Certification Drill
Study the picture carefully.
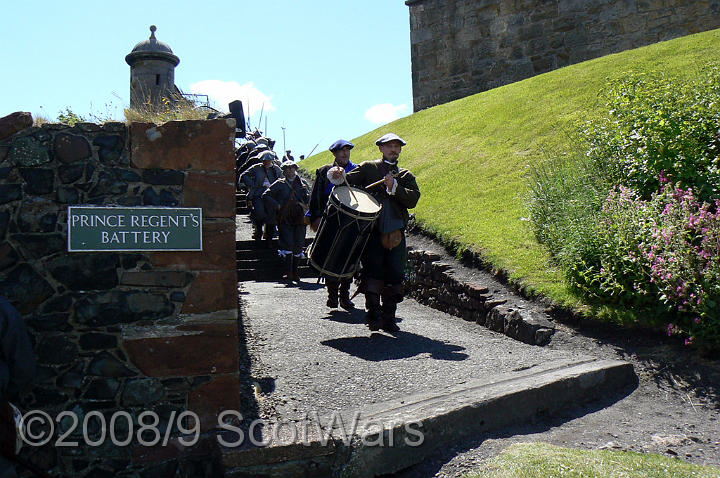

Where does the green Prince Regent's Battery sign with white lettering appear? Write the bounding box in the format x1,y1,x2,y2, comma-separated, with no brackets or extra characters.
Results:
68,206,202,252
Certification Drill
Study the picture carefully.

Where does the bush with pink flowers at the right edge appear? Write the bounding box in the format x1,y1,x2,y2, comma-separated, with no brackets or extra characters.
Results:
566,186,720,346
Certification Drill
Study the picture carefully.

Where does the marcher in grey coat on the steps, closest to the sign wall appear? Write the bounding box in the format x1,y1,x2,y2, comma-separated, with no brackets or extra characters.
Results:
239,151,282,244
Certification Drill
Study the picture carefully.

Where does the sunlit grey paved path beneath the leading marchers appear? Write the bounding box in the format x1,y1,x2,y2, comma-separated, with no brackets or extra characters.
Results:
226,216,632,476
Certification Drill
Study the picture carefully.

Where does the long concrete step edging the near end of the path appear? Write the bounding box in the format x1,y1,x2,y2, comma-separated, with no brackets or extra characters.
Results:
221,360,637,478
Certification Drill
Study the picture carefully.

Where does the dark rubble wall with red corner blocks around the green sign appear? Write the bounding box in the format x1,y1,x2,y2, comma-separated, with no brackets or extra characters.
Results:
0,115,240,478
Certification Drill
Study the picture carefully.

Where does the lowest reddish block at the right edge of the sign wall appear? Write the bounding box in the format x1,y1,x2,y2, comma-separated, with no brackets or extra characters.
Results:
188,374,242,431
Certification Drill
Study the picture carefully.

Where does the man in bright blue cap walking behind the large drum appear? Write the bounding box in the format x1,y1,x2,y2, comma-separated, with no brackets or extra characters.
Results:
308,139,357,310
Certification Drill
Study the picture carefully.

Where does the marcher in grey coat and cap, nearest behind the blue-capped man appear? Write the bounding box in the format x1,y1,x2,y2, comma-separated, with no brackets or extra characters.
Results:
262,160,310,282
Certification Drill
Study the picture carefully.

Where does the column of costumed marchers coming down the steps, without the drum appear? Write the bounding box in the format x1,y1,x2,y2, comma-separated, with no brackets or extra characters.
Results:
238,133,420,332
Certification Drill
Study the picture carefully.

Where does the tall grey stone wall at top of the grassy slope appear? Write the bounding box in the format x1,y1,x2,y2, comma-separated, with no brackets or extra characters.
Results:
405,0,720,111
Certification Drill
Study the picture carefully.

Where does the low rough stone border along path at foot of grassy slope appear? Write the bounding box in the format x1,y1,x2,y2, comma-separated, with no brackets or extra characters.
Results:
405,249,555,345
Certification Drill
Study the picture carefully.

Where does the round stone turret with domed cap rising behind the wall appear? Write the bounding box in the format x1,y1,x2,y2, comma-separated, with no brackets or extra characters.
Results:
125,25,180,109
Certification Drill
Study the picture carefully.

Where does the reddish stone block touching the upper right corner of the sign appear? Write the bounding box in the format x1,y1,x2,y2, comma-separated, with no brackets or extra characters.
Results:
184,171,235,218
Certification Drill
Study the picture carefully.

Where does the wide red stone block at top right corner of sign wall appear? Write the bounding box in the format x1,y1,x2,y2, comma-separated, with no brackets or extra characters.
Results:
130,119,235,172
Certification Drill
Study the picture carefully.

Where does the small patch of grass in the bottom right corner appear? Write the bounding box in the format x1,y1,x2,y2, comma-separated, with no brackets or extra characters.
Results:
465,443,720,478
